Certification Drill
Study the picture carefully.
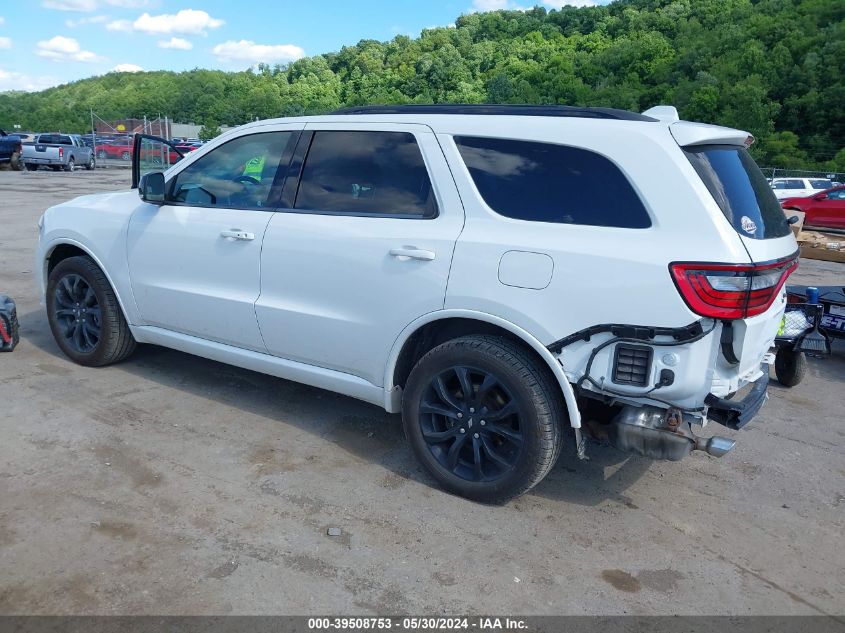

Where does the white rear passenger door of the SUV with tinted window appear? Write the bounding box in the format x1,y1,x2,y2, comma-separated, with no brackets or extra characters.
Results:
256,123,464,386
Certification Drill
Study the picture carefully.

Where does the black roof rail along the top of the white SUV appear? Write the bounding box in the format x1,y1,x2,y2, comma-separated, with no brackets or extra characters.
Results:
332,104,657,121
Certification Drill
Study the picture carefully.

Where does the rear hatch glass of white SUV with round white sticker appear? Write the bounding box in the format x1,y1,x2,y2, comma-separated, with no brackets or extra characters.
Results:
684,145,791,240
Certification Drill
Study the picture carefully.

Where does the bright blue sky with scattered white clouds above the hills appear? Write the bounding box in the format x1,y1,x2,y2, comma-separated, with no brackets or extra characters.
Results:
0,0,608,91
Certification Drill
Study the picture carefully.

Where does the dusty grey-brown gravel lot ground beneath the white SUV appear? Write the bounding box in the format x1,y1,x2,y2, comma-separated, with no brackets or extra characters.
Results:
0,170,845,615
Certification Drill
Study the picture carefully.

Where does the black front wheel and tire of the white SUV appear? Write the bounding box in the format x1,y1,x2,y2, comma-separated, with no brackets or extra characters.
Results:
46,256,136,367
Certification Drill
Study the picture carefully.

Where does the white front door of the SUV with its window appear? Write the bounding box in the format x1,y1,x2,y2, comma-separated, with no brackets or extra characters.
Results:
127,125,302,352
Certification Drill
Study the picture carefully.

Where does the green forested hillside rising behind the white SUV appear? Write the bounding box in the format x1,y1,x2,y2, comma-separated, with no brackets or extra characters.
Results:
0,0,845,171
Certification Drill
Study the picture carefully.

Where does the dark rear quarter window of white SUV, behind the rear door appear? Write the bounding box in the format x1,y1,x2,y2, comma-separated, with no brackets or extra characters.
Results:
455,136,651,229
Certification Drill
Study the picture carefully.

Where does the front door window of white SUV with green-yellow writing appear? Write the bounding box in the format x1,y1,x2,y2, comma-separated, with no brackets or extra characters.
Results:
166,132,297,209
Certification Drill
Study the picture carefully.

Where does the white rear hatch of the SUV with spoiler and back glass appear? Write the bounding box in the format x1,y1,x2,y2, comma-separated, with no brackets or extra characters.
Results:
670,121,798,380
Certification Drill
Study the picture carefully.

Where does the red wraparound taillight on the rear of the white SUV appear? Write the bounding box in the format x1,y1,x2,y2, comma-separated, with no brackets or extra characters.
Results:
669,256,798,319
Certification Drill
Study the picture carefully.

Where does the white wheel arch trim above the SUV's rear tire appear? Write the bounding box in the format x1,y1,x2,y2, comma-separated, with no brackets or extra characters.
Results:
384,310,581,429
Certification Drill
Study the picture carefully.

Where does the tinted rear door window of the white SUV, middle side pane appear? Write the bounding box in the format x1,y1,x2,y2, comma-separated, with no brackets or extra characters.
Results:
295,131,437,217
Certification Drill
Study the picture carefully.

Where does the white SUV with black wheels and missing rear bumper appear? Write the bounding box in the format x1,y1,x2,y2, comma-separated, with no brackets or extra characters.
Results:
37,106,797,502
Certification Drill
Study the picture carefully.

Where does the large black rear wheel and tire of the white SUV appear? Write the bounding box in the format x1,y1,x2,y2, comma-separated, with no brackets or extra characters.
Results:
402,336,563,503
